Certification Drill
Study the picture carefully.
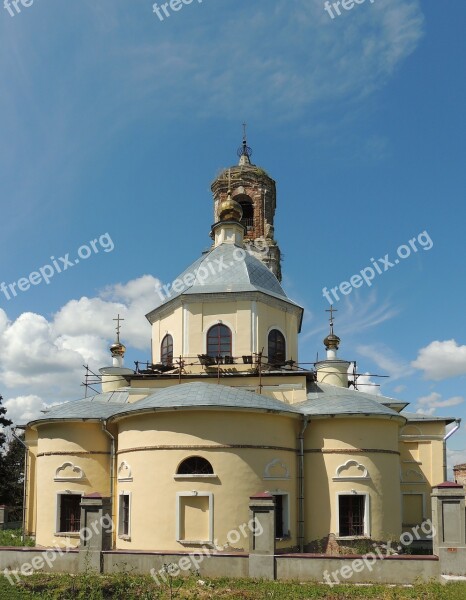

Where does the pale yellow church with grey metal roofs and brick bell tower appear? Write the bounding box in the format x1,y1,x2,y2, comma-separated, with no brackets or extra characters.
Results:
20,140,456,552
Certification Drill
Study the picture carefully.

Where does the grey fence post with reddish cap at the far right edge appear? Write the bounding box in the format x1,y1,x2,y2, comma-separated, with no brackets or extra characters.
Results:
431,481,466,576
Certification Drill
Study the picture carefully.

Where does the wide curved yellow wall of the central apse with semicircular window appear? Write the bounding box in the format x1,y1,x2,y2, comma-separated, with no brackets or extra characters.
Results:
117,411,299,550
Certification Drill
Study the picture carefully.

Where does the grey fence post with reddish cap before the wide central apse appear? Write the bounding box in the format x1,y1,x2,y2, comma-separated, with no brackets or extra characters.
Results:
249,492,275,579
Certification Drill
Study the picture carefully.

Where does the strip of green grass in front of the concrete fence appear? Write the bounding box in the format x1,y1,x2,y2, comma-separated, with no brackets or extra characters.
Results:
0,574,466,600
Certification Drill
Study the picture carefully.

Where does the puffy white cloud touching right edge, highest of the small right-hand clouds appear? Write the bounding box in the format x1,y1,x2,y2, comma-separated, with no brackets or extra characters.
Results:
411,340,466,381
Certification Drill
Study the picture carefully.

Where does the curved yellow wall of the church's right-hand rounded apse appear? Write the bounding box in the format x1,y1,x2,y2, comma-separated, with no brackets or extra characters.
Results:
305,418,401,542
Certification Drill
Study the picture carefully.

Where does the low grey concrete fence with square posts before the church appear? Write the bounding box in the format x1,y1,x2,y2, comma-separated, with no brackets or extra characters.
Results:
0,483,466,585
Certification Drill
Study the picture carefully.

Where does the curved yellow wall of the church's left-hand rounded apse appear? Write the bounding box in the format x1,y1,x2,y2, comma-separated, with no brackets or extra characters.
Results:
35,422,110,546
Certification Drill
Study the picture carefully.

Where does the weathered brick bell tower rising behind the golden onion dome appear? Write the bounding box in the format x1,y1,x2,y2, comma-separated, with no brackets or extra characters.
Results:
211,126,282,281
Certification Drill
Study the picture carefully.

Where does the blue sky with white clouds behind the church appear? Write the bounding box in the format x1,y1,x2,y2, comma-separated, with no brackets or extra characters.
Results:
0,0,466,462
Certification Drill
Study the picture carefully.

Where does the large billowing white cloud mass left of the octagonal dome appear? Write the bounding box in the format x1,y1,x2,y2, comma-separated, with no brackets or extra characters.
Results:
0,275,160,423
